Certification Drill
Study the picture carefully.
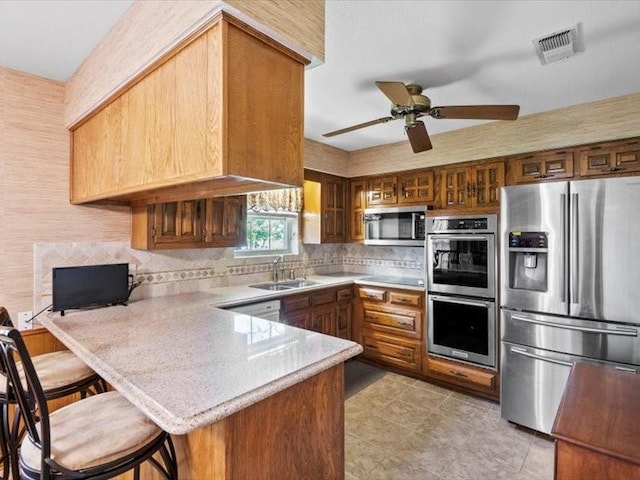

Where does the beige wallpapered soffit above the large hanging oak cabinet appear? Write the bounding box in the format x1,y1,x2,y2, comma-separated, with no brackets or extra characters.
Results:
65,0,324,125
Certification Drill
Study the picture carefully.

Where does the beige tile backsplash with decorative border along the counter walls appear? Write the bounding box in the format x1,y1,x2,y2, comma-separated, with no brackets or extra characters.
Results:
34,242,424,311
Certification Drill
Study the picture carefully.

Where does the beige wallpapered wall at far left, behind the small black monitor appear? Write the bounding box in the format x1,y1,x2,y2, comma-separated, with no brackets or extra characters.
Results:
0,68,130,320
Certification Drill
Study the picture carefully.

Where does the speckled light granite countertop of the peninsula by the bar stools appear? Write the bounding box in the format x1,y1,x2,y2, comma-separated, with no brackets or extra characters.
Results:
40,292,362,434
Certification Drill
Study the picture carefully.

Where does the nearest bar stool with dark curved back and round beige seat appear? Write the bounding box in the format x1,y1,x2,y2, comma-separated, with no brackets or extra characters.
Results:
0,327,178,480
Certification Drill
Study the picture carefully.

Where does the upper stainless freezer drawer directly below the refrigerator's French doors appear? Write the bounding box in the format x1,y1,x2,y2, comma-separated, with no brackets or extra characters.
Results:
500,309,640,365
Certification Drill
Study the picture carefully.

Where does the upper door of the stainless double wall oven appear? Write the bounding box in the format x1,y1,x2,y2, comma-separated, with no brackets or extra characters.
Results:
427,234,496,298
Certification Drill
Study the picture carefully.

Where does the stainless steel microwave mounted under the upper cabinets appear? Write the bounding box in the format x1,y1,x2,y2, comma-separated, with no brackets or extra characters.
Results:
364,206,427,247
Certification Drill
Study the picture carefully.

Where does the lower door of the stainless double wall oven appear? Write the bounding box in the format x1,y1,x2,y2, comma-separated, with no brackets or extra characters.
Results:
427,295,497,368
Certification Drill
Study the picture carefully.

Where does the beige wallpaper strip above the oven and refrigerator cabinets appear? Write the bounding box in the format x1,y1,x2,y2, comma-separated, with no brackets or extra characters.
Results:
343,93,640,177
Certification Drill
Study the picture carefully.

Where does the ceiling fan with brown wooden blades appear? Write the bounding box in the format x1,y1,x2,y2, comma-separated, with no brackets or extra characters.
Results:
323,82,520,153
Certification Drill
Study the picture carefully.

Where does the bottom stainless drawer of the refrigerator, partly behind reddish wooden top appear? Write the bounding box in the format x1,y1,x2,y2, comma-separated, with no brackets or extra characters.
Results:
500,342,640,434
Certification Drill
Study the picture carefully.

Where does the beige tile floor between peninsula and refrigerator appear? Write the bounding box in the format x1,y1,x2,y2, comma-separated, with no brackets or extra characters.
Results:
345,362,553,480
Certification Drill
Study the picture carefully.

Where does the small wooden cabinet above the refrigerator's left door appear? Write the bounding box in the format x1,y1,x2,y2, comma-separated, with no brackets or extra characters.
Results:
509,150,573,185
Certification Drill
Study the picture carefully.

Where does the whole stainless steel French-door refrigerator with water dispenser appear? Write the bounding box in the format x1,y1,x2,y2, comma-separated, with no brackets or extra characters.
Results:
500,177,640,433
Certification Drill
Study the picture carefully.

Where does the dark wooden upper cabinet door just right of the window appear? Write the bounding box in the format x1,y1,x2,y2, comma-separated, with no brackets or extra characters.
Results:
321,176,347,243
